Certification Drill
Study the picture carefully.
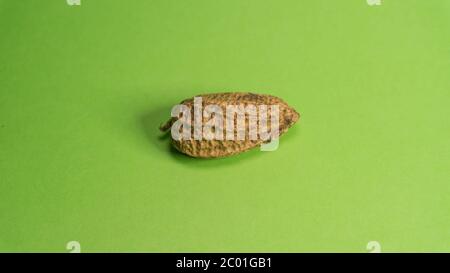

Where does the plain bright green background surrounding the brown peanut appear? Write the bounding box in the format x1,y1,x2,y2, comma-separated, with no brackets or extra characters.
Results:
0,0,450,252
